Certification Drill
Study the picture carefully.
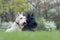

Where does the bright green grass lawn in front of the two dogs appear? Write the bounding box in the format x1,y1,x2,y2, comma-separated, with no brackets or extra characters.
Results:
0,31,60,40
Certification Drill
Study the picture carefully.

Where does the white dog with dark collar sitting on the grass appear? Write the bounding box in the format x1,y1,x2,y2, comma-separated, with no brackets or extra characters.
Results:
6,12,26,32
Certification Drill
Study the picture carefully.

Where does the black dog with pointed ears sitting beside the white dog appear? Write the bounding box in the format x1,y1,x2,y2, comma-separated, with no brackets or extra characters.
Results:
23,14,37,31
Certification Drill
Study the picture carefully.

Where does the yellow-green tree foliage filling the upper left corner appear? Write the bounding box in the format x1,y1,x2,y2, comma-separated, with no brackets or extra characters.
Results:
0,0,27,14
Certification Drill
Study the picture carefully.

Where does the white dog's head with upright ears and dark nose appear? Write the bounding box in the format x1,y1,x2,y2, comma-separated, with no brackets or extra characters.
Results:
15,12,27,26
